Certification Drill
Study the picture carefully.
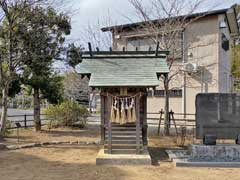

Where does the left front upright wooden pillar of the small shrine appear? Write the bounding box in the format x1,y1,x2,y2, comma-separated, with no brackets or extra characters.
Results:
107,96,112,154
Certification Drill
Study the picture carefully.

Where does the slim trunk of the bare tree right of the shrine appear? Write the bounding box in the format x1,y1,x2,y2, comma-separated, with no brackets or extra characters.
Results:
164,75,170,136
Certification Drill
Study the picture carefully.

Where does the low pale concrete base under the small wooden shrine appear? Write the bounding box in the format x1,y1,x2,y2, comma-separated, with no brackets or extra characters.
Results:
96,149,152,165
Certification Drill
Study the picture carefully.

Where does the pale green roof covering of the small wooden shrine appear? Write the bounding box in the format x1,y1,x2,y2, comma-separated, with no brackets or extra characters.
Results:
77,57,169,87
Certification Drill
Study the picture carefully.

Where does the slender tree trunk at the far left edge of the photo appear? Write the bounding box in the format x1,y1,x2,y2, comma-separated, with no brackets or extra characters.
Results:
0,86,8,136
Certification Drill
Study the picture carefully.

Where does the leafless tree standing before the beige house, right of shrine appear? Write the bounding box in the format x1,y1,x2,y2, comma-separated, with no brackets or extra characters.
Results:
129,0,220,135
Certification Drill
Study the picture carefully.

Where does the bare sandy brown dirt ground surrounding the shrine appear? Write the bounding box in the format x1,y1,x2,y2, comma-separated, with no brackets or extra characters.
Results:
0,128,240,180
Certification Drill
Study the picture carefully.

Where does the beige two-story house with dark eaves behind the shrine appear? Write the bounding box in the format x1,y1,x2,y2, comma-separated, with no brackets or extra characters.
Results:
102,8,239,113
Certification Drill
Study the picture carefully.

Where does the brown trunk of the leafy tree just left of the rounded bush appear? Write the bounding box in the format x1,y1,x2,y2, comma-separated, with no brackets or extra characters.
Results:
33,88,41,131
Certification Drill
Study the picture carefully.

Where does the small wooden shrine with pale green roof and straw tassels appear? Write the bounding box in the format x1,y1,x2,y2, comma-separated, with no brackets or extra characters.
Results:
78,51,169,154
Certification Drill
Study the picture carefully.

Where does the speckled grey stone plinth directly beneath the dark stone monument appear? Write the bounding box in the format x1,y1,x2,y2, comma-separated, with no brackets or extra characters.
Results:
189,144,240,159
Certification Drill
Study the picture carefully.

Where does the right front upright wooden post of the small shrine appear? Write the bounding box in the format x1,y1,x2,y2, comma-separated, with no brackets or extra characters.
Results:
136,96,140,154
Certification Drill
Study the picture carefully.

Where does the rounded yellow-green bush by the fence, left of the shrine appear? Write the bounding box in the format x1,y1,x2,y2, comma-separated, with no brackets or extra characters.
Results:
44,101,89,128
